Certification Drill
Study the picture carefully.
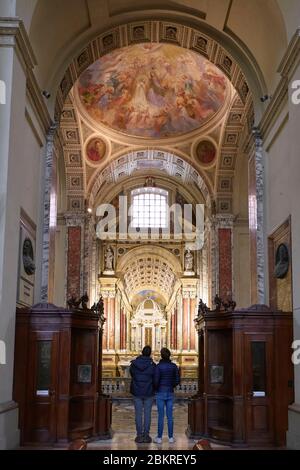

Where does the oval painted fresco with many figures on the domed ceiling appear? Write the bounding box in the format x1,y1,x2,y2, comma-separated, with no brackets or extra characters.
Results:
77,44,227,139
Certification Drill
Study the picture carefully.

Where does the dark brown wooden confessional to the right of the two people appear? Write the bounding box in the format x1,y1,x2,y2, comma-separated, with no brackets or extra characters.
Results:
187,305,294,446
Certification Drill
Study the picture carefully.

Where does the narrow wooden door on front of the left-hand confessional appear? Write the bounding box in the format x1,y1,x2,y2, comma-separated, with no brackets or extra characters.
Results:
24,331,59,443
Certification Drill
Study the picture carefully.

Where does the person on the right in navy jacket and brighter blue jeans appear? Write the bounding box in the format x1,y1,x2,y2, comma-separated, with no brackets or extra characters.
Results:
154,348,180,444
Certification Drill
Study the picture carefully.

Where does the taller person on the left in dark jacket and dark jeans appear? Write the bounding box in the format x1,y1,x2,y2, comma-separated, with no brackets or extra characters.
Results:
129,346,155,443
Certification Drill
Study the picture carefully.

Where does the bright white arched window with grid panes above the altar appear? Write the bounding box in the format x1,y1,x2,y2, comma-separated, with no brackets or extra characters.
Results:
131,187,168,228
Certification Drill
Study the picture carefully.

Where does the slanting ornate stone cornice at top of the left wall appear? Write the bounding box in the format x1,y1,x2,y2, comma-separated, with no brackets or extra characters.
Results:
0,18,51,134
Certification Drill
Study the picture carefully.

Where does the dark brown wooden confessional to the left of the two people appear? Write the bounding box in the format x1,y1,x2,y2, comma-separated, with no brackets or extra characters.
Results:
14,304,111,445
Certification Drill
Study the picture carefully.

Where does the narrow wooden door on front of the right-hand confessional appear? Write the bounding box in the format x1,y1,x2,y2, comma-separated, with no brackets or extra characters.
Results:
244,334,274,446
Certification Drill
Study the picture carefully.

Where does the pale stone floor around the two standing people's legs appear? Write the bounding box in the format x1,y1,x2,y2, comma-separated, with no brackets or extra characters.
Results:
88,402,226,450
